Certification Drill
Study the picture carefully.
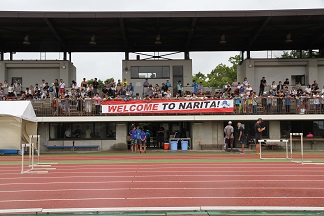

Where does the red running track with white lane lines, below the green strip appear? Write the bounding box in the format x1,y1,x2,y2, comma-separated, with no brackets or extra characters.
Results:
0,162,324,209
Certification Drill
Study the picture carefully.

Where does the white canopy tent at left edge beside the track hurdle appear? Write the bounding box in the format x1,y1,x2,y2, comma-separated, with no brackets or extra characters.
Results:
0,101,37,150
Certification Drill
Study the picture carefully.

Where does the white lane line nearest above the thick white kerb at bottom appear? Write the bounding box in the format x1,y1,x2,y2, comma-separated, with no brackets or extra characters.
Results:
0,196,324,203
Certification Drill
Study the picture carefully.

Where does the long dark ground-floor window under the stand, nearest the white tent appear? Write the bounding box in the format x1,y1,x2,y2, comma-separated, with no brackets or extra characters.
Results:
49,122,116,140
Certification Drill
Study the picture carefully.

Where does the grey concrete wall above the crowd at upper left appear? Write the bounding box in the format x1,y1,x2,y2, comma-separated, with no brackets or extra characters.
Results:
0,60,76,88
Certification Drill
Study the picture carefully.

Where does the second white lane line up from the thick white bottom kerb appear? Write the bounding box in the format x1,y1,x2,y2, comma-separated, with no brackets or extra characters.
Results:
0,187,324,194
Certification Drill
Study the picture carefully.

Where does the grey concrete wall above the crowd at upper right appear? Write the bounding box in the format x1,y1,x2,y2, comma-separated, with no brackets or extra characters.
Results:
237,59,324,92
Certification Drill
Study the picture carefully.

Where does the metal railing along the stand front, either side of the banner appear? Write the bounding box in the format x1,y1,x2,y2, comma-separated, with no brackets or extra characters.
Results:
24,97,324,117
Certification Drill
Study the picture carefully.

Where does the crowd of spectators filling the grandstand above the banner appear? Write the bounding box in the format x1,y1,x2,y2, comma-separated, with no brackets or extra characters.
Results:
0,77,324,115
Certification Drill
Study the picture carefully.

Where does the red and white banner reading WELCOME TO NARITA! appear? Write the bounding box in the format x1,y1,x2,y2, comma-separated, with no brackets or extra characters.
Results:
102,100,234,114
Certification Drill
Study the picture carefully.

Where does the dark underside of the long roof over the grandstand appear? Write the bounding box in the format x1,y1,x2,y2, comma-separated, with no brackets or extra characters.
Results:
0,9,324,52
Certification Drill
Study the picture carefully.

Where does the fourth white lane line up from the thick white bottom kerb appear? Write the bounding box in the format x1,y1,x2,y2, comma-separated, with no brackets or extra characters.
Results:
0,173,324,181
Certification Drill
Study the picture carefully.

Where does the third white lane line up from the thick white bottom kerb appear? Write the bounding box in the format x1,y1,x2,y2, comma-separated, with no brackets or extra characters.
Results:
0,179,324,186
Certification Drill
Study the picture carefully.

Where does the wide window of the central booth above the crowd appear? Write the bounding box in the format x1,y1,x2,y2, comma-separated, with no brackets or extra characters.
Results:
131,66,170,79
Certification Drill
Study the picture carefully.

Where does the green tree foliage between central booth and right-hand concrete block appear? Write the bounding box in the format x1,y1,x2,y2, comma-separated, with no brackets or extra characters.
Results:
192,55,240,88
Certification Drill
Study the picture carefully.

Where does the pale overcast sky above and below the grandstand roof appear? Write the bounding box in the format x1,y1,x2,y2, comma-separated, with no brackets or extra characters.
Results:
0,0,324,83
